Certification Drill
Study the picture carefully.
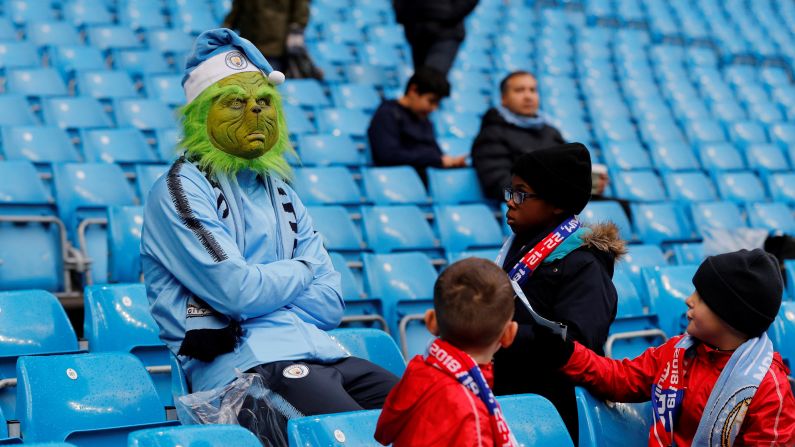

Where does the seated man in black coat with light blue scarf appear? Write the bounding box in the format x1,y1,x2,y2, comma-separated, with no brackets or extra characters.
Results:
472,71,564,200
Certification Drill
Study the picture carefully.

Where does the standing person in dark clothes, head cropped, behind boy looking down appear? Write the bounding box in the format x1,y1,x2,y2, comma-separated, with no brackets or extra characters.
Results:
393,0,478,75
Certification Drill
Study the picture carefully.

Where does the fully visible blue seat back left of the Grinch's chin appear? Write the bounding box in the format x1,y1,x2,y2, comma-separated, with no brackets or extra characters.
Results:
81,128,159,166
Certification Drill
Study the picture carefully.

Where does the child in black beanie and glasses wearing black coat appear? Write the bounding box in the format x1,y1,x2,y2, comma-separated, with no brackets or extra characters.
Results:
494,143,625,444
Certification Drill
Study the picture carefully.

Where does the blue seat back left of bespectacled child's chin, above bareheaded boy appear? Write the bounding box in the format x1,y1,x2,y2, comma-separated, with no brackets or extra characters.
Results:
434,204,503,252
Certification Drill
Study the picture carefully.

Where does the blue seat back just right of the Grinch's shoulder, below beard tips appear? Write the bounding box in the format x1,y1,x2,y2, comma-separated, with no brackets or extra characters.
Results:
293,166,363,205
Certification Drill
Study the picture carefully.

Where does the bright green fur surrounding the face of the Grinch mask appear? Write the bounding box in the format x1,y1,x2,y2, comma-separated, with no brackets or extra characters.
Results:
177,78,298,180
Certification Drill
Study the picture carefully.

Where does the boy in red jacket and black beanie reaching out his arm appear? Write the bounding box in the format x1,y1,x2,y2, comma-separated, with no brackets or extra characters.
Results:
543,249,795,447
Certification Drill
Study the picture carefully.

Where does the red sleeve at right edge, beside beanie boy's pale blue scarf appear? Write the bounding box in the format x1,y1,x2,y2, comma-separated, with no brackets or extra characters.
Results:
737,360,795,446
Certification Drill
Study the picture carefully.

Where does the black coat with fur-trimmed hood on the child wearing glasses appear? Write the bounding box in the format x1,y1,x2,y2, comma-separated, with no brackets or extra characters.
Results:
494,224,625,445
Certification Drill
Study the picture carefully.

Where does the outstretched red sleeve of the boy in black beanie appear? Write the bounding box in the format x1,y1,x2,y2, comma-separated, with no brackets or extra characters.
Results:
561,337,679,402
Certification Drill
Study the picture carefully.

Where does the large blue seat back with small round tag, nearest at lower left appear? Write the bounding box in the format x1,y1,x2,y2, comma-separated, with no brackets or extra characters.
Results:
17,353,176,446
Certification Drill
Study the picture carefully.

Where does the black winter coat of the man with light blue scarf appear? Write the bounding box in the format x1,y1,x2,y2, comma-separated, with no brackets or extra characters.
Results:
472,109,565,200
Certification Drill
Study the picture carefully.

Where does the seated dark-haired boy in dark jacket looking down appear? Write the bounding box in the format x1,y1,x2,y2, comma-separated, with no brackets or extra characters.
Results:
367,68,466,181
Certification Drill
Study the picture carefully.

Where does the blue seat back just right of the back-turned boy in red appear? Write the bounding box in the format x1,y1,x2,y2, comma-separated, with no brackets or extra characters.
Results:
497,394,574,447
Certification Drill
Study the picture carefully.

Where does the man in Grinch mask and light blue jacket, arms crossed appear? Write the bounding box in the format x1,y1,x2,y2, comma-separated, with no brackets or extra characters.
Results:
141,29,397,442
